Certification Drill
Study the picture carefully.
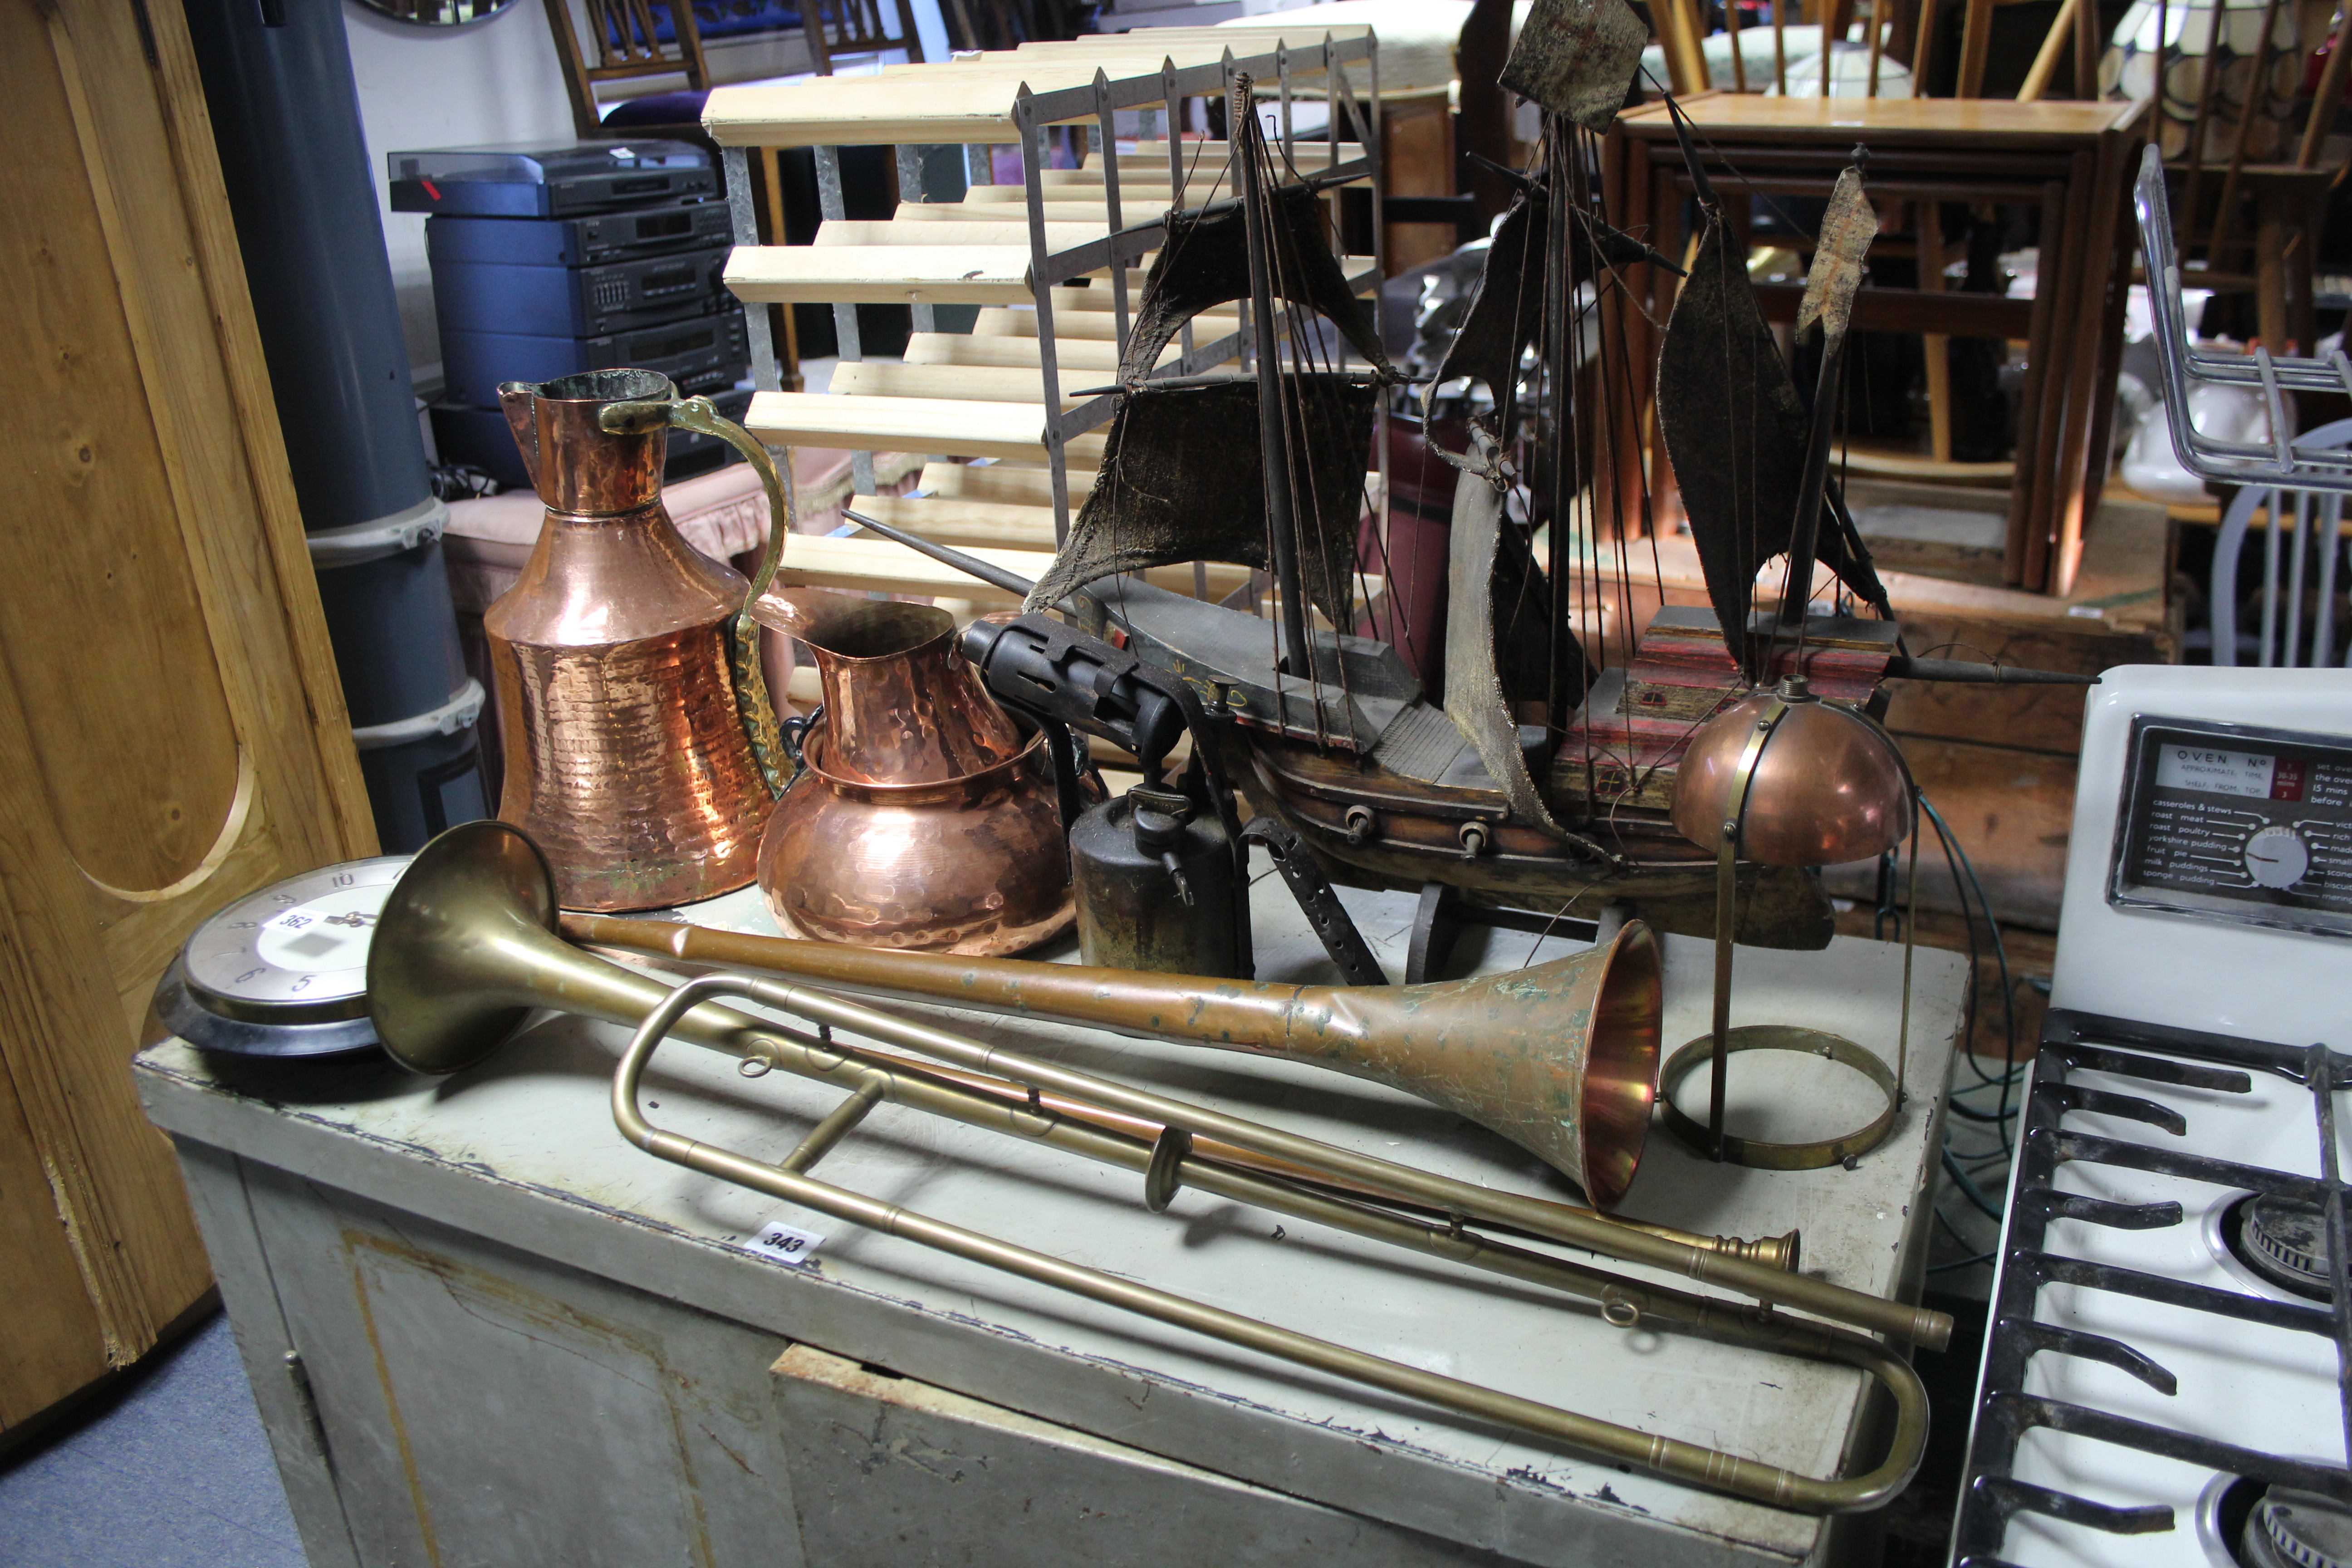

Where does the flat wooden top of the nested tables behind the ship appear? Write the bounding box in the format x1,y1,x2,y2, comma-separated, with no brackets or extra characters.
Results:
1618,92,2147,153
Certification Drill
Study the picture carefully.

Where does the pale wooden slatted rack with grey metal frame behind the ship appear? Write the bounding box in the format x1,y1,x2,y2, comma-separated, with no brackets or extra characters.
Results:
703,26,1385,592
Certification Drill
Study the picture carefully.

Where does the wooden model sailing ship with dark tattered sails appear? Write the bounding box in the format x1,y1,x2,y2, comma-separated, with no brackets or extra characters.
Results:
870,0,2077,947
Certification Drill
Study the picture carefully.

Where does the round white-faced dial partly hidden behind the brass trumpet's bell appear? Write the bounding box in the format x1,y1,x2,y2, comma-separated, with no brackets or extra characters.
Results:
155,856,412,1058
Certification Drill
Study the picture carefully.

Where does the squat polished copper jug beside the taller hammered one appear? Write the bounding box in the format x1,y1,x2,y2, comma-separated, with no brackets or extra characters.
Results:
753,590,1075,957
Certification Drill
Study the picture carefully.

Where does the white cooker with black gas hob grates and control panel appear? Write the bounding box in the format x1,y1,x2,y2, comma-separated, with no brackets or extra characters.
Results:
1952,665,2352,1568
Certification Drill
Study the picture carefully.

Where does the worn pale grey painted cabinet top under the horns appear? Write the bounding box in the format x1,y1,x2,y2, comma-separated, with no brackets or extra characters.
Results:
139,877,1966,1563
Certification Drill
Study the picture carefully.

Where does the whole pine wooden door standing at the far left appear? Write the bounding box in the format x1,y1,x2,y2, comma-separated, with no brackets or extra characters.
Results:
0,0,376,1425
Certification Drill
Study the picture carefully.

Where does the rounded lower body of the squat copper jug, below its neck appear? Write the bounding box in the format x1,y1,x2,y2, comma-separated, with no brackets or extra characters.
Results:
760,720,1077,957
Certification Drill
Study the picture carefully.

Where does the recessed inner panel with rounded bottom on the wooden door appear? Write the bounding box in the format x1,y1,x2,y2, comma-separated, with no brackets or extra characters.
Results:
0,7,238,893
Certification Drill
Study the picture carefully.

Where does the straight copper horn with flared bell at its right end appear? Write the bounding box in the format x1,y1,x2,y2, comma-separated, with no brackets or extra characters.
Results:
562,879,1663,1208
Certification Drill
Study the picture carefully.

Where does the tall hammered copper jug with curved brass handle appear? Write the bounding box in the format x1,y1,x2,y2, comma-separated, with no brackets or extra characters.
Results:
482,369,788,910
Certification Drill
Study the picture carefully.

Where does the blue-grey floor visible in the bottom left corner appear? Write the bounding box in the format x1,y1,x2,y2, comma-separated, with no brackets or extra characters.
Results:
0,1314,304,1568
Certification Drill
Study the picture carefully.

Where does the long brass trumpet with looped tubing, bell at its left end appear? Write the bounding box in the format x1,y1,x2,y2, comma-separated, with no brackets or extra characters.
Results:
367,820,1952,1514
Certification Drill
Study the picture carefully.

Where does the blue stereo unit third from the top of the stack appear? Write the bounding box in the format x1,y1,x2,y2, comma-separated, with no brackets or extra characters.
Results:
433,245,734,338
